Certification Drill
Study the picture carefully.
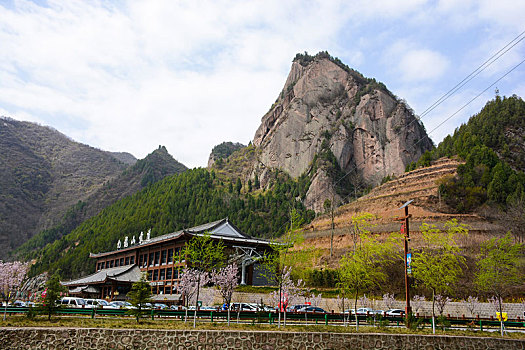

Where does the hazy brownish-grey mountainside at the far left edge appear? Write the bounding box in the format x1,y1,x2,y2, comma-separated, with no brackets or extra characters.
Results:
0,117,127,259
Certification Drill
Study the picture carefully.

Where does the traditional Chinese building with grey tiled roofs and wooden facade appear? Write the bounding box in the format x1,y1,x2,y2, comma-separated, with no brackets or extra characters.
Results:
62,219,270,303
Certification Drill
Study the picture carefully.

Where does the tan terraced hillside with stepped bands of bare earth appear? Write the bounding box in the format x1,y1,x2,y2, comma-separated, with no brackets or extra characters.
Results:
296,158,500,265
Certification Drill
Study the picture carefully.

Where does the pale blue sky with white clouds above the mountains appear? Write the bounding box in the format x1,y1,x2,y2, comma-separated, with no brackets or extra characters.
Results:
0,0,525,167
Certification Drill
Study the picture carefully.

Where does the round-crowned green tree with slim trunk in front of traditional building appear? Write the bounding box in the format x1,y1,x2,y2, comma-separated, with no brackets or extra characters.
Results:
182,233,226,327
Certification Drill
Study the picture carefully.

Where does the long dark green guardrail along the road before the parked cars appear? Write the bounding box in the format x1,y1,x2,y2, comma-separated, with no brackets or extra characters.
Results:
0,307,525,331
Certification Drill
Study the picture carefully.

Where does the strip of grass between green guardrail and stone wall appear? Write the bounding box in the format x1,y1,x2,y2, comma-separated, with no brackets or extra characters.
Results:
0,316,525,340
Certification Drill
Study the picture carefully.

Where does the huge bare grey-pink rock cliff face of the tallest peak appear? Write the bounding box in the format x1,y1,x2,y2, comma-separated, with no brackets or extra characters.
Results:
253,54,432,211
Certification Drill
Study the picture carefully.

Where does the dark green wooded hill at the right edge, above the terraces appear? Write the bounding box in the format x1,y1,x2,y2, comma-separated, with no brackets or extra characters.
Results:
407,95,525,213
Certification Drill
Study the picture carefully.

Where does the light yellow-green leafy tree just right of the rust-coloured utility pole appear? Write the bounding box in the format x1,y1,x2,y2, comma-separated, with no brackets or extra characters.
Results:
412,219,468,333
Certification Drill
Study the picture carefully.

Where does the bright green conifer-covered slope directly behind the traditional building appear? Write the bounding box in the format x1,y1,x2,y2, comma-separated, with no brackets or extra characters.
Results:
27,169,314,278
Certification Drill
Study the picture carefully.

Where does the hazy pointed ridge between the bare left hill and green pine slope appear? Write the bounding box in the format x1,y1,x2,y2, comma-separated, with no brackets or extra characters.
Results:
15,146,187,256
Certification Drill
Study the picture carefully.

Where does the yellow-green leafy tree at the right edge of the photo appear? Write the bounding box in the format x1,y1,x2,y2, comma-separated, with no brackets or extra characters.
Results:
475,233,524,336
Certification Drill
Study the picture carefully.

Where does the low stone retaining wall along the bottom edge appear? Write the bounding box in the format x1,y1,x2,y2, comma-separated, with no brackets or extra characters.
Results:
0,328,525,350
